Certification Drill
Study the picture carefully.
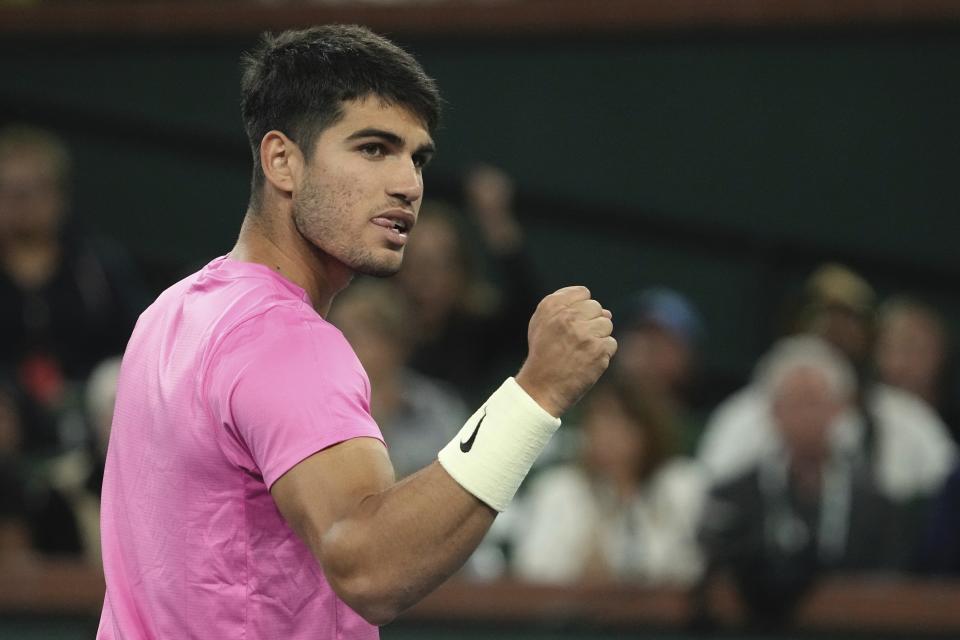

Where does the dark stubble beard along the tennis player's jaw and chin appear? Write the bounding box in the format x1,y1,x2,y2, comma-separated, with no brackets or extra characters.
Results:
293,184,403,278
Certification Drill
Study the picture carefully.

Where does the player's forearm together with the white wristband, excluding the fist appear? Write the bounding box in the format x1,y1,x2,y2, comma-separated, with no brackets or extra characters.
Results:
314,380,560,622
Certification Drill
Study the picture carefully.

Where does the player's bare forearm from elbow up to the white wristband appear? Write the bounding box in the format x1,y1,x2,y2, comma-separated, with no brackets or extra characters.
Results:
312,463,496,624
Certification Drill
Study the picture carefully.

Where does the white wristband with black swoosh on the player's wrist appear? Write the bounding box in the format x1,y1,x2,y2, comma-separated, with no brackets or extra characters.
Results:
437,378,560,511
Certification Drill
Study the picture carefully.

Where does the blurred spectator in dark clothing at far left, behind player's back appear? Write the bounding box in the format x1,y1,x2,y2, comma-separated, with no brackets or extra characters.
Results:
0,125,146,451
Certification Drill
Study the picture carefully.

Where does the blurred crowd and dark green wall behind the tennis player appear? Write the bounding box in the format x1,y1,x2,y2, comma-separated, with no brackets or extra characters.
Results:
0,0,960,637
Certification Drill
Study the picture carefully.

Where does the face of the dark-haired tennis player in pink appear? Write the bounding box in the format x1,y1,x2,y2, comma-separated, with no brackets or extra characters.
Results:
291,98,433,276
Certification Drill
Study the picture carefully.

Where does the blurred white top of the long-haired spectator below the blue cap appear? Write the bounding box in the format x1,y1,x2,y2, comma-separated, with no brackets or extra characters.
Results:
513,458,706,585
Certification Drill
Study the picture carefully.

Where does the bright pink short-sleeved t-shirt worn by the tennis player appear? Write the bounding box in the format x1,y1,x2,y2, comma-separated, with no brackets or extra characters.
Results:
97,258,382,640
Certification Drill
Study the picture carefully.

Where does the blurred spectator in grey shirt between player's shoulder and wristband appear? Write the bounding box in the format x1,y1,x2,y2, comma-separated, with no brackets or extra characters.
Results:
330,280,470,478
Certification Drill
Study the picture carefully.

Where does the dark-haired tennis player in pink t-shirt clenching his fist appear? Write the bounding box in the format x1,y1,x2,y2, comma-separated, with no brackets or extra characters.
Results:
97,26,616,640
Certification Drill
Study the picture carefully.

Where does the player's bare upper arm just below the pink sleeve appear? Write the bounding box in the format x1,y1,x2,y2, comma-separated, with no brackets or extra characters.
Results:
270,437,395,555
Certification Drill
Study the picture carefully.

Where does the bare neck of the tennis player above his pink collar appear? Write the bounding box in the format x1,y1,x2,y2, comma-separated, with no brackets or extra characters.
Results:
230,208,353,318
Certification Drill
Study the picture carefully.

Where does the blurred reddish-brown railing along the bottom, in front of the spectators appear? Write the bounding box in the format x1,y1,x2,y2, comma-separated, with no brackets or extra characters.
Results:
0,562,960,637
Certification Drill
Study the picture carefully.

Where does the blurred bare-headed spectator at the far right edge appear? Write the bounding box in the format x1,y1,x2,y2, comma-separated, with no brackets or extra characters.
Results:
874,296,960,439
